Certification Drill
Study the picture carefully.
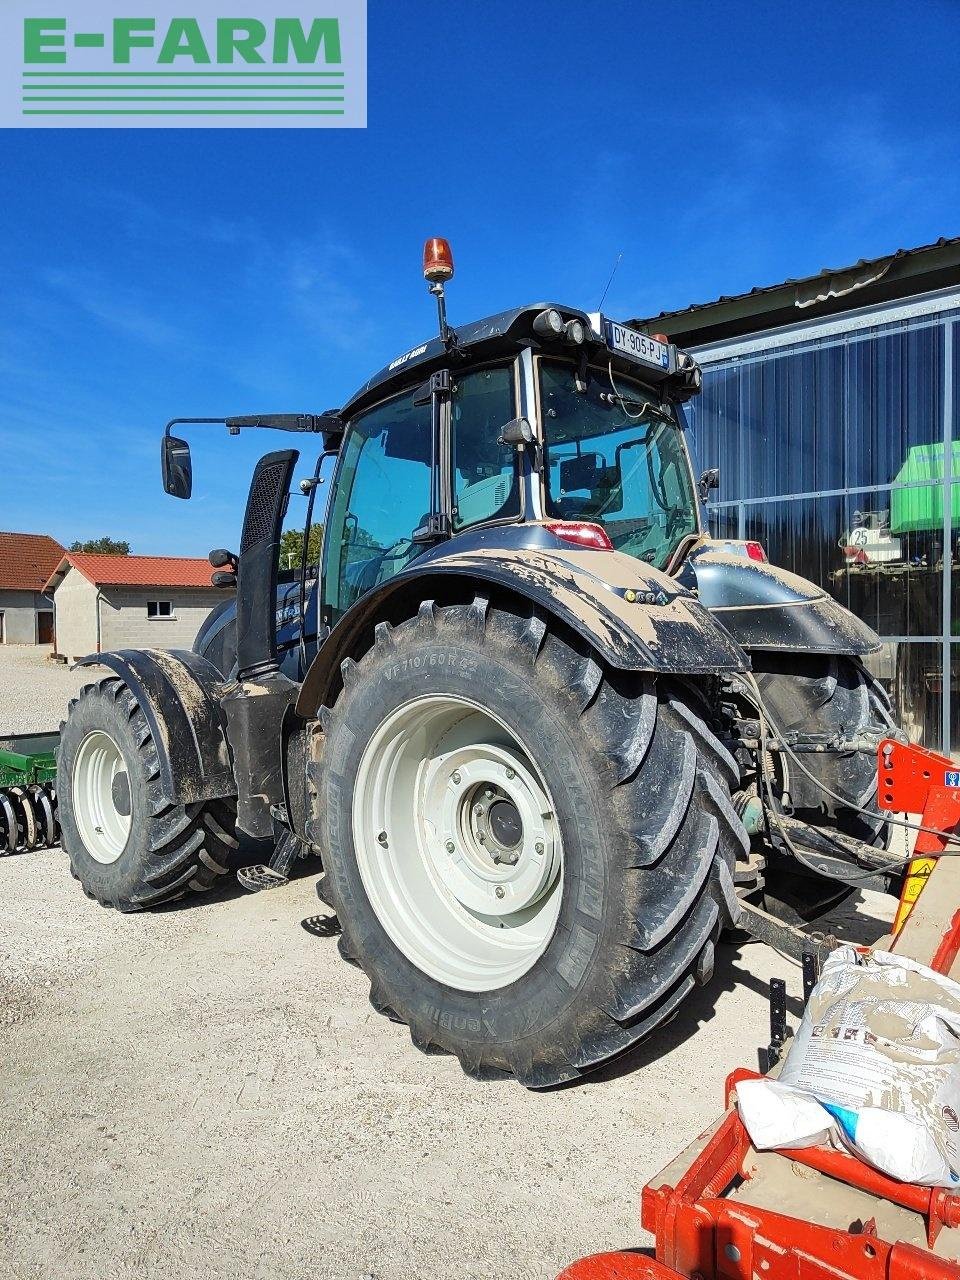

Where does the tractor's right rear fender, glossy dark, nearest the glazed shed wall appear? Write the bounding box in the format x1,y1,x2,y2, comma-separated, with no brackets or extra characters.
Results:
687,543,881,658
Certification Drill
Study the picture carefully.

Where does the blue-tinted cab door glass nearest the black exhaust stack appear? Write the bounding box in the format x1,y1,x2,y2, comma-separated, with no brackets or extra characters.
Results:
324,392,431,625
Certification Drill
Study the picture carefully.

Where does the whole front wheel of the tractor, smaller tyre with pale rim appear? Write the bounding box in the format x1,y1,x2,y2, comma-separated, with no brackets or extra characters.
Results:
56,676,237,911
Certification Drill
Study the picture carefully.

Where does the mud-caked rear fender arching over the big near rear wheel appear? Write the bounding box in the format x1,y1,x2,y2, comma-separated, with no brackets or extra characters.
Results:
297,526,749,718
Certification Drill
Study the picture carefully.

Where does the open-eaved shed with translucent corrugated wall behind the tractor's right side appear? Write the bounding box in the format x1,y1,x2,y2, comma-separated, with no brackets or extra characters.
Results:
632,237,960,751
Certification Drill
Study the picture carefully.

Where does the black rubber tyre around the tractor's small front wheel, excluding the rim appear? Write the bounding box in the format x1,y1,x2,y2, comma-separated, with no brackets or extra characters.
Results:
56,676,237,911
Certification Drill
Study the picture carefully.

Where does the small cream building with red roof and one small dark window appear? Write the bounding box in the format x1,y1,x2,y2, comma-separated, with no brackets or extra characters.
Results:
46,552,232,662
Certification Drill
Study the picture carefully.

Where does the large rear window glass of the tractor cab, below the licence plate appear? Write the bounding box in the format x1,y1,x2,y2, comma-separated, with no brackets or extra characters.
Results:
540,361,699,568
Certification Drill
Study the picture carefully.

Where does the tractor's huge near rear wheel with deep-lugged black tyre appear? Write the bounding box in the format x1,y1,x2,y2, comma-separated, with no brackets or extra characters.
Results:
315,598,748,1088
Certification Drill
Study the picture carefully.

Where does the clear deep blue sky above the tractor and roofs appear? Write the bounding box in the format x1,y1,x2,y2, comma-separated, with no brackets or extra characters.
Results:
0,0,960,556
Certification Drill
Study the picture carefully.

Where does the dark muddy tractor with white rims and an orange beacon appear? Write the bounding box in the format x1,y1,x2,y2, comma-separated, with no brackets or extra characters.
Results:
58,239,897,1087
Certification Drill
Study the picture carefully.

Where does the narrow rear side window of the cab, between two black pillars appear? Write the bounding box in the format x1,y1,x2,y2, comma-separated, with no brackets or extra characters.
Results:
451,365,520,531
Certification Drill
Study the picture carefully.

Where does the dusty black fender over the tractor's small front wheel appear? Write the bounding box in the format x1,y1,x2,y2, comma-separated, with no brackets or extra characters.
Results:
76,649,237,804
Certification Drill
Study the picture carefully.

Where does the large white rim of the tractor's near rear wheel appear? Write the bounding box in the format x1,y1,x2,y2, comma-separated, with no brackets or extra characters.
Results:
352,695,563,991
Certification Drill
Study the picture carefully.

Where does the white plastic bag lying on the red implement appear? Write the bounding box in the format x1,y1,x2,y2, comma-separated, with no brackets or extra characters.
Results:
736,947,960,1188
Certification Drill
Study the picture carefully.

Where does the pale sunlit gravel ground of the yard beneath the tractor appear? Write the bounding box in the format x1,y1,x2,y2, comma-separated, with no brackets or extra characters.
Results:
0,650,892,1280
